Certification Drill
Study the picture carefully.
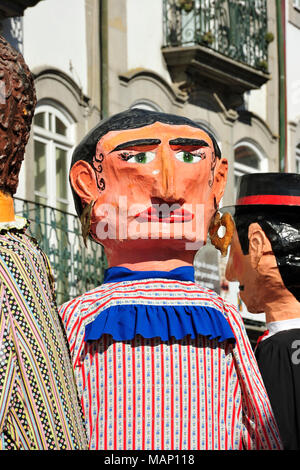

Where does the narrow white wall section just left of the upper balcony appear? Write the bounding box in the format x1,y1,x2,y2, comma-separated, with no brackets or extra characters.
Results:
127,0,171,83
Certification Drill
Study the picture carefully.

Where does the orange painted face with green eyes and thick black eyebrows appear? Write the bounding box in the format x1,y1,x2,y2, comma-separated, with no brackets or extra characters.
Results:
91,122,218,252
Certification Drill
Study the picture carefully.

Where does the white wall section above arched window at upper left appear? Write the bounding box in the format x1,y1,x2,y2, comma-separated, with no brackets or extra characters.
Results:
24,0,87,94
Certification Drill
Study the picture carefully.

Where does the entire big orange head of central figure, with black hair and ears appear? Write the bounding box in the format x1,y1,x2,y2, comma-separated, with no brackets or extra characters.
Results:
70,109,227,265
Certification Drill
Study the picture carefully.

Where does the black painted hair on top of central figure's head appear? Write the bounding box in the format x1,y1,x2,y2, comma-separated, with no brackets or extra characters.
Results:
71,108,221,216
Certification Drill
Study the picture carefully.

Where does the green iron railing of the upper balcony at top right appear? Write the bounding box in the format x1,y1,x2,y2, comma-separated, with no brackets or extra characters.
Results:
164,0,273,72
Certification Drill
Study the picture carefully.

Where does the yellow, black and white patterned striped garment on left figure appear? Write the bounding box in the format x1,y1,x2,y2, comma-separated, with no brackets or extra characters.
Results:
0,219,87,450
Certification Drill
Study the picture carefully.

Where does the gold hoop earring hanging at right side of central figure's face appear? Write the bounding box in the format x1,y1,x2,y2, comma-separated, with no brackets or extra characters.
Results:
208,212,234,256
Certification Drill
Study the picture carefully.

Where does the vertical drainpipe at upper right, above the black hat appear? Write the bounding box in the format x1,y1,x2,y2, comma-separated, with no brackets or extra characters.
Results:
276,0,287,172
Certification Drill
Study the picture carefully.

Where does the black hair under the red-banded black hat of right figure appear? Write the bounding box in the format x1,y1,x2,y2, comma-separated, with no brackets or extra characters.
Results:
234,206,300,301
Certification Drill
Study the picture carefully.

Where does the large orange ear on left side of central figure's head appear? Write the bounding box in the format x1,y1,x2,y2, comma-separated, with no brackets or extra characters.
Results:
70,160,99,204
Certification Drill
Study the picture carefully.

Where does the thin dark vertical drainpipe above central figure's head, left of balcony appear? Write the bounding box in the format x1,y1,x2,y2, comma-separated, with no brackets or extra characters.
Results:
99,0,108,119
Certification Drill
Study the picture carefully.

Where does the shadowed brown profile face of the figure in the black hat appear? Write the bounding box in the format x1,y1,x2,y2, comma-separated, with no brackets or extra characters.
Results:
225,230,264,313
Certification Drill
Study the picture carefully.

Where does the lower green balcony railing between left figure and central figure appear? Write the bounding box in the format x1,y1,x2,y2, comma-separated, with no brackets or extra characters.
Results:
14,198,107,305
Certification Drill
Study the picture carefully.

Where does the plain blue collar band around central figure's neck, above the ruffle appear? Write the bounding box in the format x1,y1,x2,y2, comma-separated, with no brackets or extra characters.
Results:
103,266,195,284
